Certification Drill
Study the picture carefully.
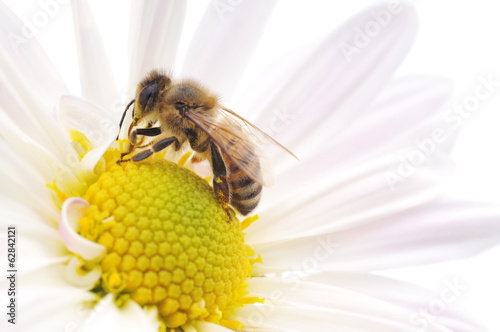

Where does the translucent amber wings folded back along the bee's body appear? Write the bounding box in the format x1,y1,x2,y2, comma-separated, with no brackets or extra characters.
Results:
186,108,297,186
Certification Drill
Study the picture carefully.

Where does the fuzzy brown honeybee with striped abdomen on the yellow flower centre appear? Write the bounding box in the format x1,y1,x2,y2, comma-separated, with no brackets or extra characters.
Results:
118,70,296,220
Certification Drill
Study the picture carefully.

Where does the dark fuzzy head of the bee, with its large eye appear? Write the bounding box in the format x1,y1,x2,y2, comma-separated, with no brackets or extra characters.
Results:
132,70,172,125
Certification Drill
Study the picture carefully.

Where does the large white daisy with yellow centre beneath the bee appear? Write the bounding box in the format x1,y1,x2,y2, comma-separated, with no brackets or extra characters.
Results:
0,1,500,332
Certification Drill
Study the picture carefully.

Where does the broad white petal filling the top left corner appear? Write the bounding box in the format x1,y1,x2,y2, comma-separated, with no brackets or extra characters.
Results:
0,3,73,159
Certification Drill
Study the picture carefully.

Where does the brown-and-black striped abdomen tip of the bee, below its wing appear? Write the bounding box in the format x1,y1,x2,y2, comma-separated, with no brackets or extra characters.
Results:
229,173,262,215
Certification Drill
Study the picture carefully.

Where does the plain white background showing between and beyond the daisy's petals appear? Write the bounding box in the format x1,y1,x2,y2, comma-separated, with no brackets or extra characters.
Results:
6,0,500,331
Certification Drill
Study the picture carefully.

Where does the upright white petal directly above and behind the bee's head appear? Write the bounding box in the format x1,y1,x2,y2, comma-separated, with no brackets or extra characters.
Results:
128,0,187,96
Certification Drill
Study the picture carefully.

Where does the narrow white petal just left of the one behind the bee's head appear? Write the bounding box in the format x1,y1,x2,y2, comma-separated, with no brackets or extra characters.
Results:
71,0,120,109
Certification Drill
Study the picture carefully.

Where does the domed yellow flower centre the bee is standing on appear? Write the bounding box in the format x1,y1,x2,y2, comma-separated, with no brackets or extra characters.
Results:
55,134,260,331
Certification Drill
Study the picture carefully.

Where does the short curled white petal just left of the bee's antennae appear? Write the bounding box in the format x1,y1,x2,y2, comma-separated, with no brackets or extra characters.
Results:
58,96,118,174
